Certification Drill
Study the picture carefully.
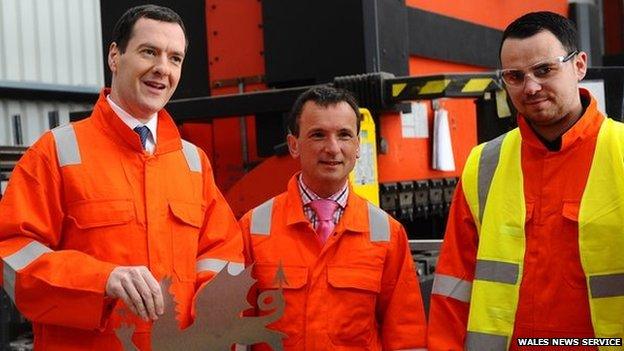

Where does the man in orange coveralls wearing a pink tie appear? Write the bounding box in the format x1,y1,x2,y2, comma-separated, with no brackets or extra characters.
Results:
240,87,425,350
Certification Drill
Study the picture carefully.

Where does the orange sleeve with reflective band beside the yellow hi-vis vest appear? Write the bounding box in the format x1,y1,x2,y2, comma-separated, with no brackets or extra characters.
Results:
427,181,479,351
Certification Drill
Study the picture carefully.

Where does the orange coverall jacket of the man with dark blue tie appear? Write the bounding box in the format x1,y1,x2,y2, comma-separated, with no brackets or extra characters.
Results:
0,90,243,351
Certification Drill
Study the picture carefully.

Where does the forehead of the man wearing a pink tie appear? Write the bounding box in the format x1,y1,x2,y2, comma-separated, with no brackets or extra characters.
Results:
299,101,357,131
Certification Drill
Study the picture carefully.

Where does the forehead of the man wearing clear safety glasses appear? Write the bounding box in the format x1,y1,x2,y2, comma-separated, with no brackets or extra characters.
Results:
501,30,567,68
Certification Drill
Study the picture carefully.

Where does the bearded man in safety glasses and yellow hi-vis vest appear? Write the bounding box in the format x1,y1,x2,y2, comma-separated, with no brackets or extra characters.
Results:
428,12,624,351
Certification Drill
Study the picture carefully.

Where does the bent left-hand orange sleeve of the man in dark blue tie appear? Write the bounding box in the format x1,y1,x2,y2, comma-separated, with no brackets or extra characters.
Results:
0,139,114,329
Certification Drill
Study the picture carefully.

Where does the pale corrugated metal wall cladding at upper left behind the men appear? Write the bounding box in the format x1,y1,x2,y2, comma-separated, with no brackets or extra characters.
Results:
0,0,104,145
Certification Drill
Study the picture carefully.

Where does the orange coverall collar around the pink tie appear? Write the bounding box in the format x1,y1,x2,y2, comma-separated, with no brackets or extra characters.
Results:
285,172,368,232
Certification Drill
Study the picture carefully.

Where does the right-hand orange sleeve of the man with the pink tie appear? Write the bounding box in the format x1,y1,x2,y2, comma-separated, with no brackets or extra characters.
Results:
377,220,427,350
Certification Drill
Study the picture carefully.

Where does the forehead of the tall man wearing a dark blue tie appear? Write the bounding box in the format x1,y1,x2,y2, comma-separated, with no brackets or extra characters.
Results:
128,17,186,52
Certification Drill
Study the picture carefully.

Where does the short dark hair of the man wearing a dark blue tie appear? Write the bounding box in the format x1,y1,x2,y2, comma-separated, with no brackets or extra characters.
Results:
113,4,188,54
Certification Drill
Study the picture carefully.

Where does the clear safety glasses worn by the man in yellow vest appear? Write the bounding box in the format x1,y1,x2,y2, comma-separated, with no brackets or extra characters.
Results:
498,50,578,87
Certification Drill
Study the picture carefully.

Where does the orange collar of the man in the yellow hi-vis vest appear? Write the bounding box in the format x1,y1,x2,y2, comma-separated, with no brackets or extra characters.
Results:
518,88,605,153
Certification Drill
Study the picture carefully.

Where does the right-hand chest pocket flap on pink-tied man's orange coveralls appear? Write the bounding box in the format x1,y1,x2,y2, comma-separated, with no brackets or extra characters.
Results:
327,266,381,293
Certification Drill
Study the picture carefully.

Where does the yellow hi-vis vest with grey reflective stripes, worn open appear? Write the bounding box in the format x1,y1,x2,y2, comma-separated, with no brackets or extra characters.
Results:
462,119,624,351
